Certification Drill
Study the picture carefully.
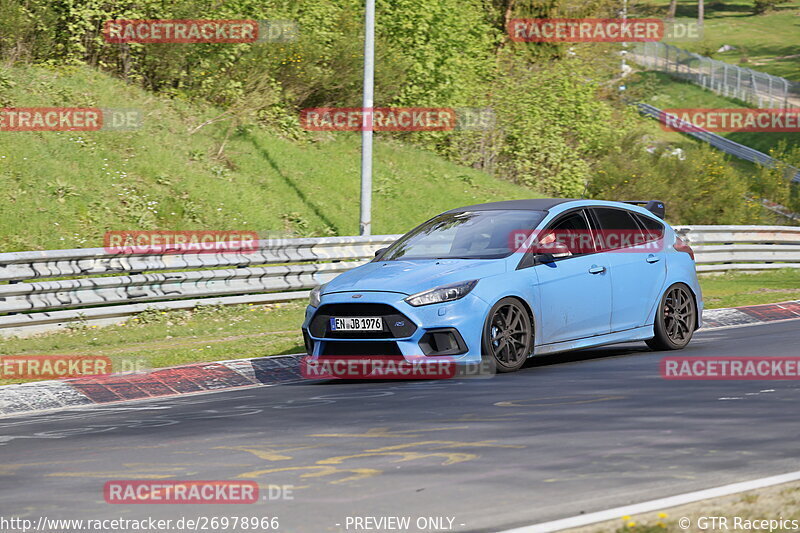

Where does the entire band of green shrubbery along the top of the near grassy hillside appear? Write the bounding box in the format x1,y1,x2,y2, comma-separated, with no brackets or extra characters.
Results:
0,0,783,223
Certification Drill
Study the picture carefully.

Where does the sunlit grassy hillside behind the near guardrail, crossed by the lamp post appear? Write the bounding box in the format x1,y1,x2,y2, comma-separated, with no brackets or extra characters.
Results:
0,66,538,251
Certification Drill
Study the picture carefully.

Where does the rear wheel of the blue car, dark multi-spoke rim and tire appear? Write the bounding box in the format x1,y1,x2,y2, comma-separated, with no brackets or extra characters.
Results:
645,283,697,351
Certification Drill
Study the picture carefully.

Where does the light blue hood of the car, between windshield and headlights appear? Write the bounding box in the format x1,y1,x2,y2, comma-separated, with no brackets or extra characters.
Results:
323,259,506,295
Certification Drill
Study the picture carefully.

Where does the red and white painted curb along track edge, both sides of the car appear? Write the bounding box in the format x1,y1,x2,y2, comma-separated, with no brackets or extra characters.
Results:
0,300,800,416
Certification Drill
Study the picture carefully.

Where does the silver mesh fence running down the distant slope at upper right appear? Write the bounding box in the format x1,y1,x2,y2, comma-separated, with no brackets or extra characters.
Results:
630,42,800,108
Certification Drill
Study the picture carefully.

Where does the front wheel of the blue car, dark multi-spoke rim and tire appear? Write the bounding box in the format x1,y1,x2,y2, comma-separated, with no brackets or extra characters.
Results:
481,298,533,372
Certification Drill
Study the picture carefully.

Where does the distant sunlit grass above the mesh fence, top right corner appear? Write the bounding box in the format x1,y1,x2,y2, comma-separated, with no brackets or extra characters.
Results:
632,0,800,81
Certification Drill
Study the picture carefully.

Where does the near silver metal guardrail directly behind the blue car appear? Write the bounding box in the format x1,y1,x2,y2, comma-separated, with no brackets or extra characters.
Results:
0,226,800,336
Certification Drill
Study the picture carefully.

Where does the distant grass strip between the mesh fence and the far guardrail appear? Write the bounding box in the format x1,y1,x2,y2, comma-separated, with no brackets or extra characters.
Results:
630,71,800,153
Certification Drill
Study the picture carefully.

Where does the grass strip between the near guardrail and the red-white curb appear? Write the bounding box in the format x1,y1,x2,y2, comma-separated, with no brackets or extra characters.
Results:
0,269,800,384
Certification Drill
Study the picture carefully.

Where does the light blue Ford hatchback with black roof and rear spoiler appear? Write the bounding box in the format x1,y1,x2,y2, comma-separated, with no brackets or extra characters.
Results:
303,199,703,372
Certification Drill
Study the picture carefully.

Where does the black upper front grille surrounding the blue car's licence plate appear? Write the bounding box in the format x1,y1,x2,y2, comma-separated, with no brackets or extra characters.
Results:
308,303,417,339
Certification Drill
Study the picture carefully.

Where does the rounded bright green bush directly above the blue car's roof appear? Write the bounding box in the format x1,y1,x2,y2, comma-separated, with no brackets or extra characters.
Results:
439,51,619,197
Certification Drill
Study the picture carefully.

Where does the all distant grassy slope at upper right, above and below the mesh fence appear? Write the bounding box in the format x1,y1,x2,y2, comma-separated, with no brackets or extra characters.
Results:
629,0,800,212
